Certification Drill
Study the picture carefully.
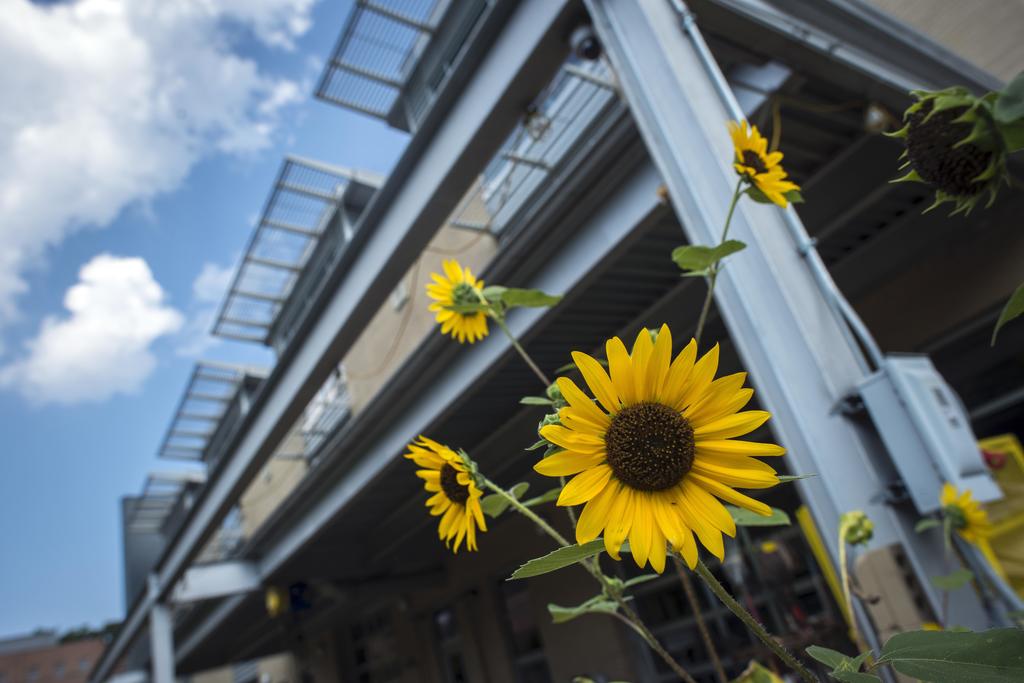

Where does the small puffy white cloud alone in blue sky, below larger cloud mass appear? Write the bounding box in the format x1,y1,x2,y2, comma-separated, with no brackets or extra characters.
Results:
0,254,183,403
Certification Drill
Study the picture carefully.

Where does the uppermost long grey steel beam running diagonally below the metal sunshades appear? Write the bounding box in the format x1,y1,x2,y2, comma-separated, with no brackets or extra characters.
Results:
90,0,572,681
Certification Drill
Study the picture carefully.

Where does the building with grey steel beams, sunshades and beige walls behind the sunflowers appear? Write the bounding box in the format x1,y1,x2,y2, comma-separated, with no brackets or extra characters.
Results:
97,0,1024,683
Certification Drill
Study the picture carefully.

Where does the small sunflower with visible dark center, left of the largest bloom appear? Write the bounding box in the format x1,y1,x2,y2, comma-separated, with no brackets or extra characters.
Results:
406,436,487,553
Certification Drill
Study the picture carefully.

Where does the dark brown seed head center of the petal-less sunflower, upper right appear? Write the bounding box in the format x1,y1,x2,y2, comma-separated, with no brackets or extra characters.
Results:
906,100,992,197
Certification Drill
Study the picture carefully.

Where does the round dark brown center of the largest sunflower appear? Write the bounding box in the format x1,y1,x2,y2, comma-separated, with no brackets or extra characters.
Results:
604,402,694,490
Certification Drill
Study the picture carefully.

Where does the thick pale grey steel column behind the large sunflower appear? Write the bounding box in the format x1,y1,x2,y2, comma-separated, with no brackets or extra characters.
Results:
586,0,986,626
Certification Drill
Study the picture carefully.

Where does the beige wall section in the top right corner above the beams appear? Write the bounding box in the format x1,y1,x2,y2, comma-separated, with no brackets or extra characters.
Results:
868,0,1024,81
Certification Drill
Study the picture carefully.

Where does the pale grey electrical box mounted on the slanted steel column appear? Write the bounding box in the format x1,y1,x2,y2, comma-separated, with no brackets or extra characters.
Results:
859,355,1002,513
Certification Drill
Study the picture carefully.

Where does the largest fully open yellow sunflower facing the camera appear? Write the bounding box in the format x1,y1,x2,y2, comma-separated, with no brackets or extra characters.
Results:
534,326,785,572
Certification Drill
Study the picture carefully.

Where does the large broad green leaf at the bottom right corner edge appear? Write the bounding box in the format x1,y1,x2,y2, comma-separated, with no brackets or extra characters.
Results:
878,629,1024,683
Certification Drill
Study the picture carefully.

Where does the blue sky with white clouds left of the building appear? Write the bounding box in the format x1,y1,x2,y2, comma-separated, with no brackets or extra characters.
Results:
0,0,404,637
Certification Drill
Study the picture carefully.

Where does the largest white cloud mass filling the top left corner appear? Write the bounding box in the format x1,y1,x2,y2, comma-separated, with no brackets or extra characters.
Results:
0,0,315,324
